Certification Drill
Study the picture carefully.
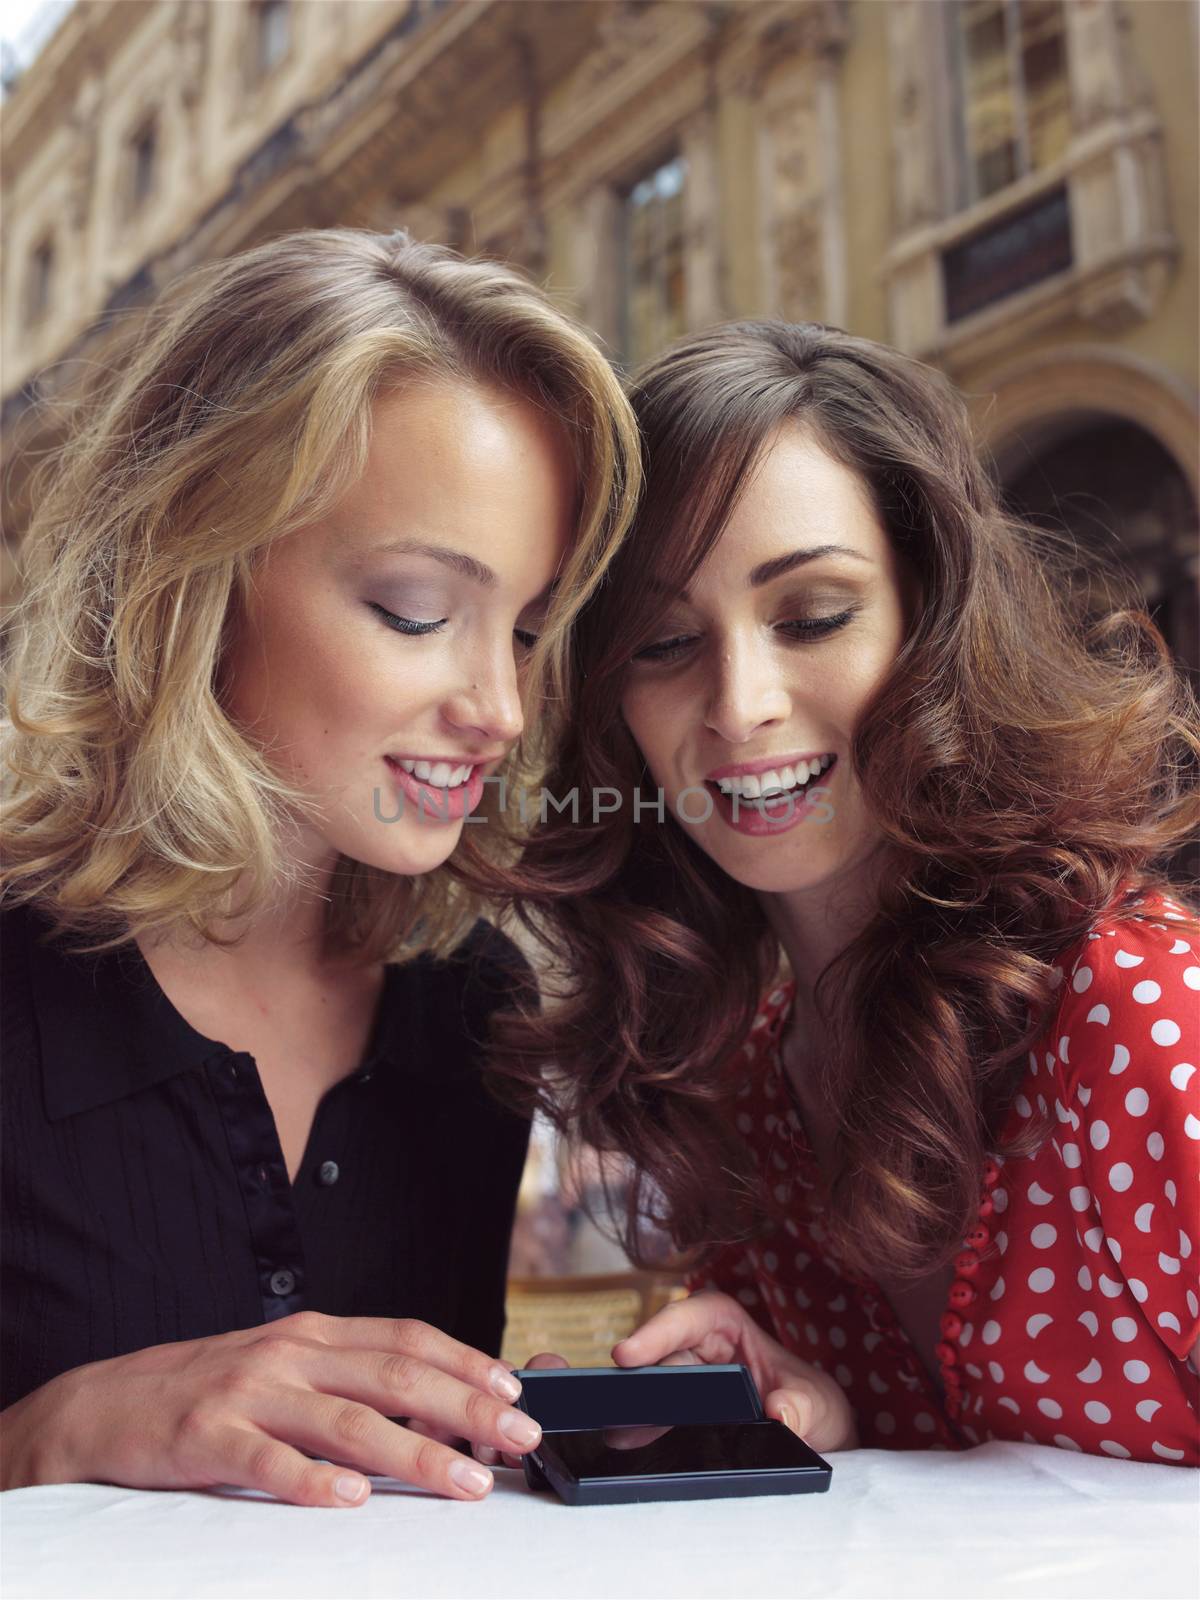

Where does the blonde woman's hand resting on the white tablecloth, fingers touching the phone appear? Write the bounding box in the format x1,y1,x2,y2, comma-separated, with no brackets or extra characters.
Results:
0,1310,541,1506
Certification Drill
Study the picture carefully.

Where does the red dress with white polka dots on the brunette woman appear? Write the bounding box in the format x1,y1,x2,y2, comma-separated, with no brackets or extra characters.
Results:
690,894,1200,1466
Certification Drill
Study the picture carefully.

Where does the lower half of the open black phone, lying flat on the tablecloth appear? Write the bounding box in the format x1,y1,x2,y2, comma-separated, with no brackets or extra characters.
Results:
525,1421,832,1506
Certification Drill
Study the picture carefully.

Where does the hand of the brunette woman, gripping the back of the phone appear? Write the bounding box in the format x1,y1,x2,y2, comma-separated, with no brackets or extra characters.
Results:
613,1290,858,1454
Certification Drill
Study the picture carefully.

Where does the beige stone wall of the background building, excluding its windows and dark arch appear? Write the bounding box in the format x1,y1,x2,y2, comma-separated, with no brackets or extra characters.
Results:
0,0,1200,544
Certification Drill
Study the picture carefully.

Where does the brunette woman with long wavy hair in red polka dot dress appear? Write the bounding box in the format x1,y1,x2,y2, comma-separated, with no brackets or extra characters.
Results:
486,322,1200,1462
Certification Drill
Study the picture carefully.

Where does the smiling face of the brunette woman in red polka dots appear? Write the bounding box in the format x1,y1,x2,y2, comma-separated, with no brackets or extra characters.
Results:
621,422,915,893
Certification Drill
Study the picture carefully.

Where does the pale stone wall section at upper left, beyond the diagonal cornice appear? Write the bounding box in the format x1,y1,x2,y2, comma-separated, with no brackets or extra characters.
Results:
0,0,406,395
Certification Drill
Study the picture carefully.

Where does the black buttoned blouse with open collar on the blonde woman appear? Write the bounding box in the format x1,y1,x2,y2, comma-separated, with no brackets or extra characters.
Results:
0,906,530,1406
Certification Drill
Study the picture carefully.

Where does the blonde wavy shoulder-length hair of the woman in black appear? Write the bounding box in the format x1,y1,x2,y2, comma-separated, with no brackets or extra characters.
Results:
0,229,640,962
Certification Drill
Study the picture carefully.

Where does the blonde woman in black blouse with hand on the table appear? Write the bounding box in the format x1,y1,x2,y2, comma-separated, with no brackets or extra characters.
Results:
0,230,638,1506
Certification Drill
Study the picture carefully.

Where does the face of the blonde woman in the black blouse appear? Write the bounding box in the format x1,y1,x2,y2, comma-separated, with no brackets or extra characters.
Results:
221,382,574,874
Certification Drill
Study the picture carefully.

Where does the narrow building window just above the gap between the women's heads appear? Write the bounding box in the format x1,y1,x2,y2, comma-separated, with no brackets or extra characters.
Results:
621,155,688,366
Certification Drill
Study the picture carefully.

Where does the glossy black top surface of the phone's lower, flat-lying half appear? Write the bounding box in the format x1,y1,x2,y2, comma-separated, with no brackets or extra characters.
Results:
542,1422,826,1480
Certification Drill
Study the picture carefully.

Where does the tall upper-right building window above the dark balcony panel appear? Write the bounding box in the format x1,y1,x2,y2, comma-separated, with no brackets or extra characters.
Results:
952,0,1070,206
